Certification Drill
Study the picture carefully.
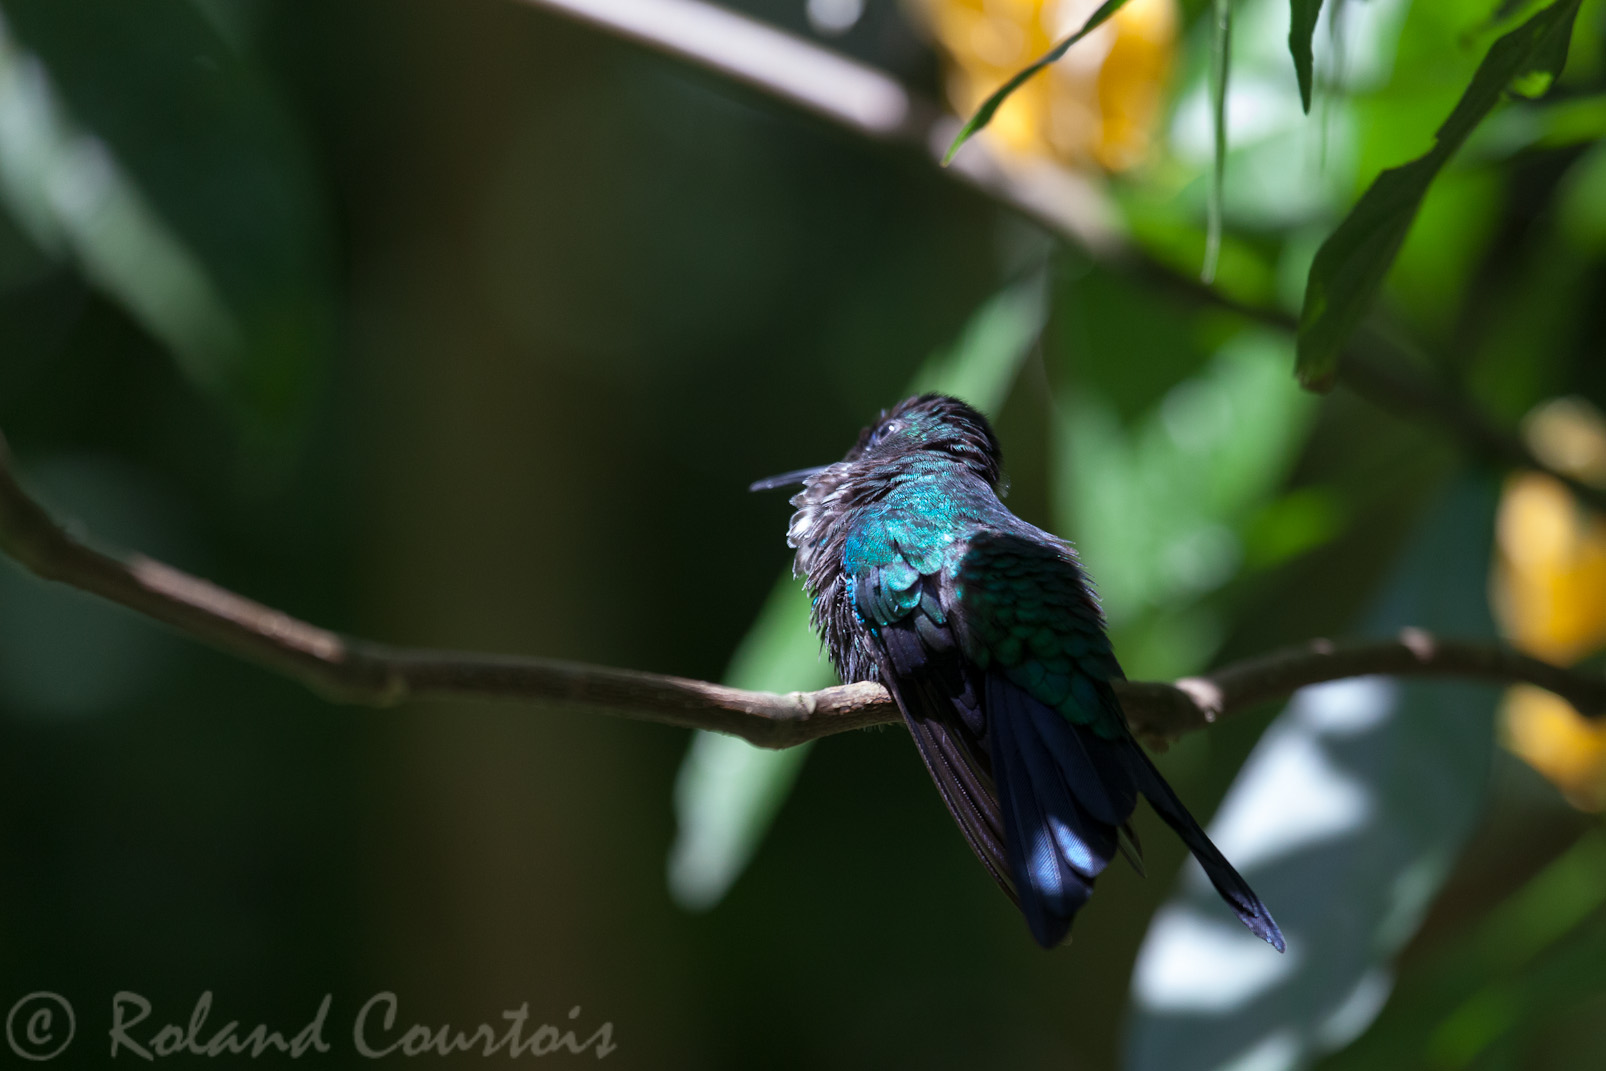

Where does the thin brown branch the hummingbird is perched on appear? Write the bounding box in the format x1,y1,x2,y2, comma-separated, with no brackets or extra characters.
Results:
0,437,1606,748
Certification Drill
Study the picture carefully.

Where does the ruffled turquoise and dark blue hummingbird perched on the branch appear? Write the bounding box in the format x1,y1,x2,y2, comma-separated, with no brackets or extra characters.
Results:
752,393,1285,952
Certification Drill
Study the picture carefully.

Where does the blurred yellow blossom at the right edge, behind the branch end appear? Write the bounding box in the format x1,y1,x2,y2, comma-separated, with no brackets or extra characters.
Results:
1495,398,1606,811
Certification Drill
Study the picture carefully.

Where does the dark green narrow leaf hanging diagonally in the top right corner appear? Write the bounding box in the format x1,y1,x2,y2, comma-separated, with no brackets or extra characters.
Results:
1298,0,1580,390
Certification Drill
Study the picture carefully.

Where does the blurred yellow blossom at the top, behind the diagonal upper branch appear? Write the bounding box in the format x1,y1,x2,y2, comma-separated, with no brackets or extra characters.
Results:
914,0,1179,170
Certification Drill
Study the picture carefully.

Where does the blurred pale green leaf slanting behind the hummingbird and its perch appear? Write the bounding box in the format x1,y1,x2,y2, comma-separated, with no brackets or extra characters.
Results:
668,275,1049,910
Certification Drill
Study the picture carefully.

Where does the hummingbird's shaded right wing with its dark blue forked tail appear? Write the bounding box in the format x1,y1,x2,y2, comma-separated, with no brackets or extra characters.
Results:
944,528,1283,951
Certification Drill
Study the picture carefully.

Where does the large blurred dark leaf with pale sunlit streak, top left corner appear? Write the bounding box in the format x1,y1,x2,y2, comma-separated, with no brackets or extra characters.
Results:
0,0,334,437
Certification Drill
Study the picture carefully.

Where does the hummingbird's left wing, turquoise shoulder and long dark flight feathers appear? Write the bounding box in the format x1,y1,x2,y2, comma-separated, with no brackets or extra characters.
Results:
848,540,1015,899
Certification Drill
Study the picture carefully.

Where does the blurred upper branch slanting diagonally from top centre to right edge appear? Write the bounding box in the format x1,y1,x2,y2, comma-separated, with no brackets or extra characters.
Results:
520,0,1606,512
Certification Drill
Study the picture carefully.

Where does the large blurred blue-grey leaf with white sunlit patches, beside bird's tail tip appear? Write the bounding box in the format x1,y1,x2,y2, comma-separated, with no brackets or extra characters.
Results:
1124,478,1500,1071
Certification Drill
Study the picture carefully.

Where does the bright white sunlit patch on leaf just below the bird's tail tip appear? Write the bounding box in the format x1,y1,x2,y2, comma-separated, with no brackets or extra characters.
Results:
1132,906,1299,1015
